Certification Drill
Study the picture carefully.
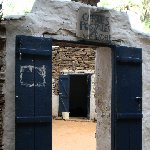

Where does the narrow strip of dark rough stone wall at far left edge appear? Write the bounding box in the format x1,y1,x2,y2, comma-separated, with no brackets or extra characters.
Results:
0,24,6,150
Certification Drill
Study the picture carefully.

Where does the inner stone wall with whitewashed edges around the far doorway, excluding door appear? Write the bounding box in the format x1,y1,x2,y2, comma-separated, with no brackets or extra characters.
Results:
52,45,96,119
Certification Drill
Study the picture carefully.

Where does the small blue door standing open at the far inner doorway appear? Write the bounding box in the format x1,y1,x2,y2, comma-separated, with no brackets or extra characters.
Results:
59,75,70,115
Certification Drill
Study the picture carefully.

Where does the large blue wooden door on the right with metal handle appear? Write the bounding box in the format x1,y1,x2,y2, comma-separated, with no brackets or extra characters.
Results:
112,46,142,150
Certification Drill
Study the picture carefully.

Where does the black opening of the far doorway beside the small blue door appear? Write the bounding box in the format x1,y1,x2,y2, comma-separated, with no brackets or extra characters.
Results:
69,75,89,117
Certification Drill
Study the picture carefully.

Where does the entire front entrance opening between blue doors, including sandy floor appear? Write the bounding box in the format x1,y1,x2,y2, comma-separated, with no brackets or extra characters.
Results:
52,41,97,150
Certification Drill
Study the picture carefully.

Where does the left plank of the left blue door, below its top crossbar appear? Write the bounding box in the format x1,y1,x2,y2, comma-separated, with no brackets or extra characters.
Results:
16,55,34,150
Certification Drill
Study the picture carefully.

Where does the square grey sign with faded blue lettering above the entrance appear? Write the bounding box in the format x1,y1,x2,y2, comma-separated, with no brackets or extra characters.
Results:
76,7,110,43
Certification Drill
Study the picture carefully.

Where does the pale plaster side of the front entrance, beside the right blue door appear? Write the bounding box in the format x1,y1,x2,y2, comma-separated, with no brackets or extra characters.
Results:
95,47,112,150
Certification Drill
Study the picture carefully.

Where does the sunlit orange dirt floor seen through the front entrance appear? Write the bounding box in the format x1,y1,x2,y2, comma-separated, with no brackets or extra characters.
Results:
52,120,96,150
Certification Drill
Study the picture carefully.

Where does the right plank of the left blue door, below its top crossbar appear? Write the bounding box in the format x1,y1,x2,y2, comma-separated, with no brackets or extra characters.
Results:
35,56,52,150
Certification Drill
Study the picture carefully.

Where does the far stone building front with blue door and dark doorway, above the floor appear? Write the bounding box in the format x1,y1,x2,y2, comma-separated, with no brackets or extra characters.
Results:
52,42,97,120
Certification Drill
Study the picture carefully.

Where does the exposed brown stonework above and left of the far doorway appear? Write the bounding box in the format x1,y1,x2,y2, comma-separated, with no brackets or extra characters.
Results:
52,47,95,95
